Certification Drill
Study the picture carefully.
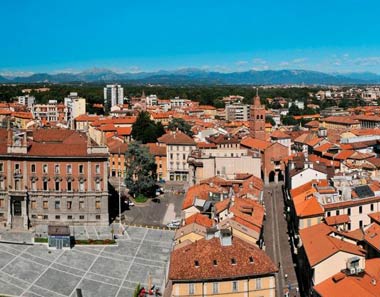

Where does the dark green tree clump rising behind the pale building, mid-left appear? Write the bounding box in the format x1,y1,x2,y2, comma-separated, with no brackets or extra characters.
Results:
132,111,165,143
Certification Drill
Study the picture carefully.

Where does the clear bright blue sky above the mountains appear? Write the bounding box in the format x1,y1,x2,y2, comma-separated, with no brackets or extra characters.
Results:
0,0,380,74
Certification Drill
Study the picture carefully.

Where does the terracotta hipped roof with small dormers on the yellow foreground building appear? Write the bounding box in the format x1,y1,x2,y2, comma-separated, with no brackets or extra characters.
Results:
169,237,277,281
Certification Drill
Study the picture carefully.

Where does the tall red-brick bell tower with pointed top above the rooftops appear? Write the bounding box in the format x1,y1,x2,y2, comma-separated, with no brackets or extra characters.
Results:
249,88,265,140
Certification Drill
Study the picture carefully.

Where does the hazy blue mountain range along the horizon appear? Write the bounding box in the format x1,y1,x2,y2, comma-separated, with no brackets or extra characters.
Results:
0,68,380,85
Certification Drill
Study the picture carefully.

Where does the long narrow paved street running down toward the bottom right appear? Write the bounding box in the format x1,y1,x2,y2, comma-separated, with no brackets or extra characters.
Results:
264,184,299,297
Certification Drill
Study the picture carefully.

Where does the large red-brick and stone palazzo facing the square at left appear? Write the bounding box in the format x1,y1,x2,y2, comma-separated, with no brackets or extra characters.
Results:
0,129,109,229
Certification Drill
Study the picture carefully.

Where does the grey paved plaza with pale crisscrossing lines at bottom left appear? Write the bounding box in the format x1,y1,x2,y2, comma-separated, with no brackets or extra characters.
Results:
0,227,174,297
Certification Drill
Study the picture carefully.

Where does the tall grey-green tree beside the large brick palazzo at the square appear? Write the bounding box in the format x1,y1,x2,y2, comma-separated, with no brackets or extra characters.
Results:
125,142,157,197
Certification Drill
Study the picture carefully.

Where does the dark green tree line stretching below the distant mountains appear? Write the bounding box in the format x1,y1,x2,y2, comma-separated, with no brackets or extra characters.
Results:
0,83,317,107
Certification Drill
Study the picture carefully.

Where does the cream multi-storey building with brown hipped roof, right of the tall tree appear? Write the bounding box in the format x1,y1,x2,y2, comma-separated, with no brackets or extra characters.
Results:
158,131,196,181
